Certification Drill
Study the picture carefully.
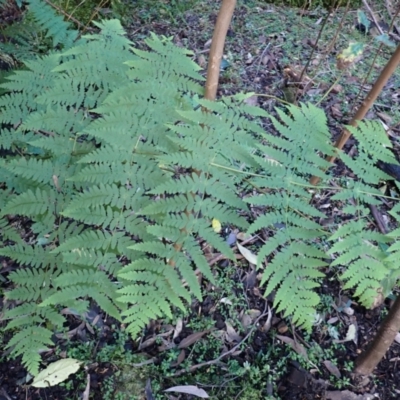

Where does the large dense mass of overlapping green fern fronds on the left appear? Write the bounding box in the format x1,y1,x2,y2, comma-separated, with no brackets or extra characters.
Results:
0,17,253,373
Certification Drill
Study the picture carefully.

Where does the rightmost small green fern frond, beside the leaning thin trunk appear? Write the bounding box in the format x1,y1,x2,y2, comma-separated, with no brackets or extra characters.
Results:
329,122,400,307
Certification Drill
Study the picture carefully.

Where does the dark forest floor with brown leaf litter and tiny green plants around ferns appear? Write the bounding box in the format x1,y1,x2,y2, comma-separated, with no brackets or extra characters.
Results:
0,0,400,400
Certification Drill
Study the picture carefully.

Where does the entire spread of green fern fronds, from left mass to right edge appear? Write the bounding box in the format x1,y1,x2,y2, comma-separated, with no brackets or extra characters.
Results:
0,5,399,374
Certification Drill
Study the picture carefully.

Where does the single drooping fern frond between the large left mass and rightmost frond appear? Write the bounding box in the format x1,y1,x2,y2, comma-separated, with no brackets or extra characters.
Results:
246,104,334,330
